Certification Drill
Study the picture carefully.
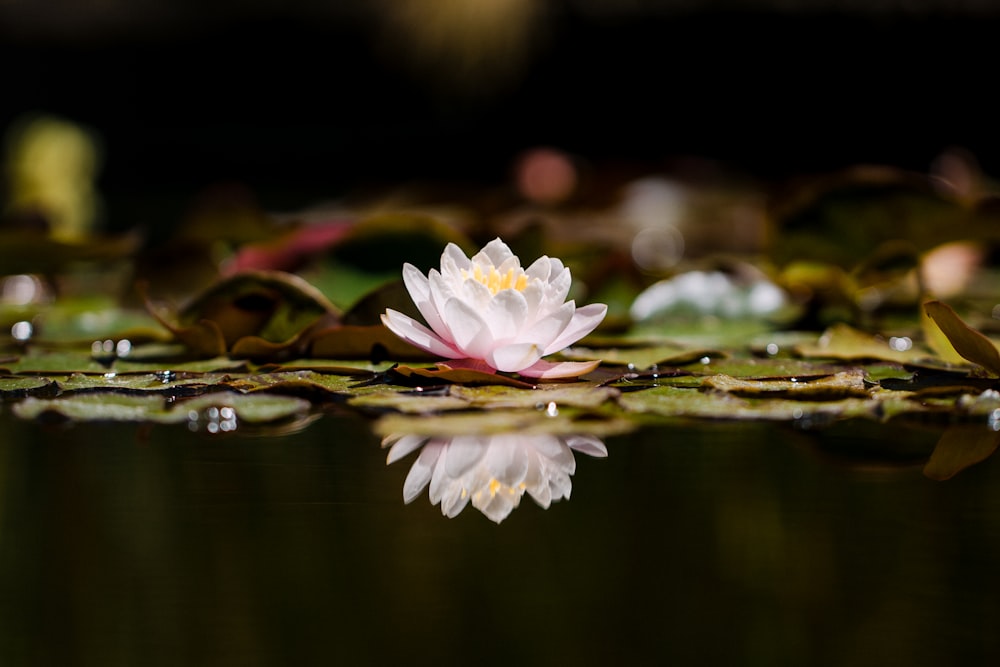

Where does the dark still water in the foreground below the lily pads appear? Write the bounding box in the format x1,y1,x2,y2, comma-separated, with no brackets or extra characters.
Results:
0,414,1000,667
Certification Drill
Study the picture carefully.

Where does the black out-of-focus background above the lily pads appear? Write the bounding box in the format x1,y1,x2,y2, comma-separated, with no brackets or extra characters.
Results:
0,0,1000,227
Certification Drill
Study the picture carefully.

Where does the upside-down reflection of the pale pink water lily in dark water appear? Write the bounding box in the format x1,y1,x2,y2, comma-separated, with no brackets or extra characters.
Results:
382,433,608,523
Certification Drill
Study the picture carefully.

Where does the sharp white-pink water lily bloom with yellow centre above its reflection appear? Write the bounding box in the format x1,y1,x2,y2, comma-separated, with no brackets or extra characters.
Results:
382,239,608,378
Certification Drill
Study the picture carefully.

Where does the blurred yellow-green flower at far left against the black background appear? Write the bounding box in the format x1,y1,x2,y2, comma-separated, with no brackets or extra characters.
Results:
4,116,100,241
